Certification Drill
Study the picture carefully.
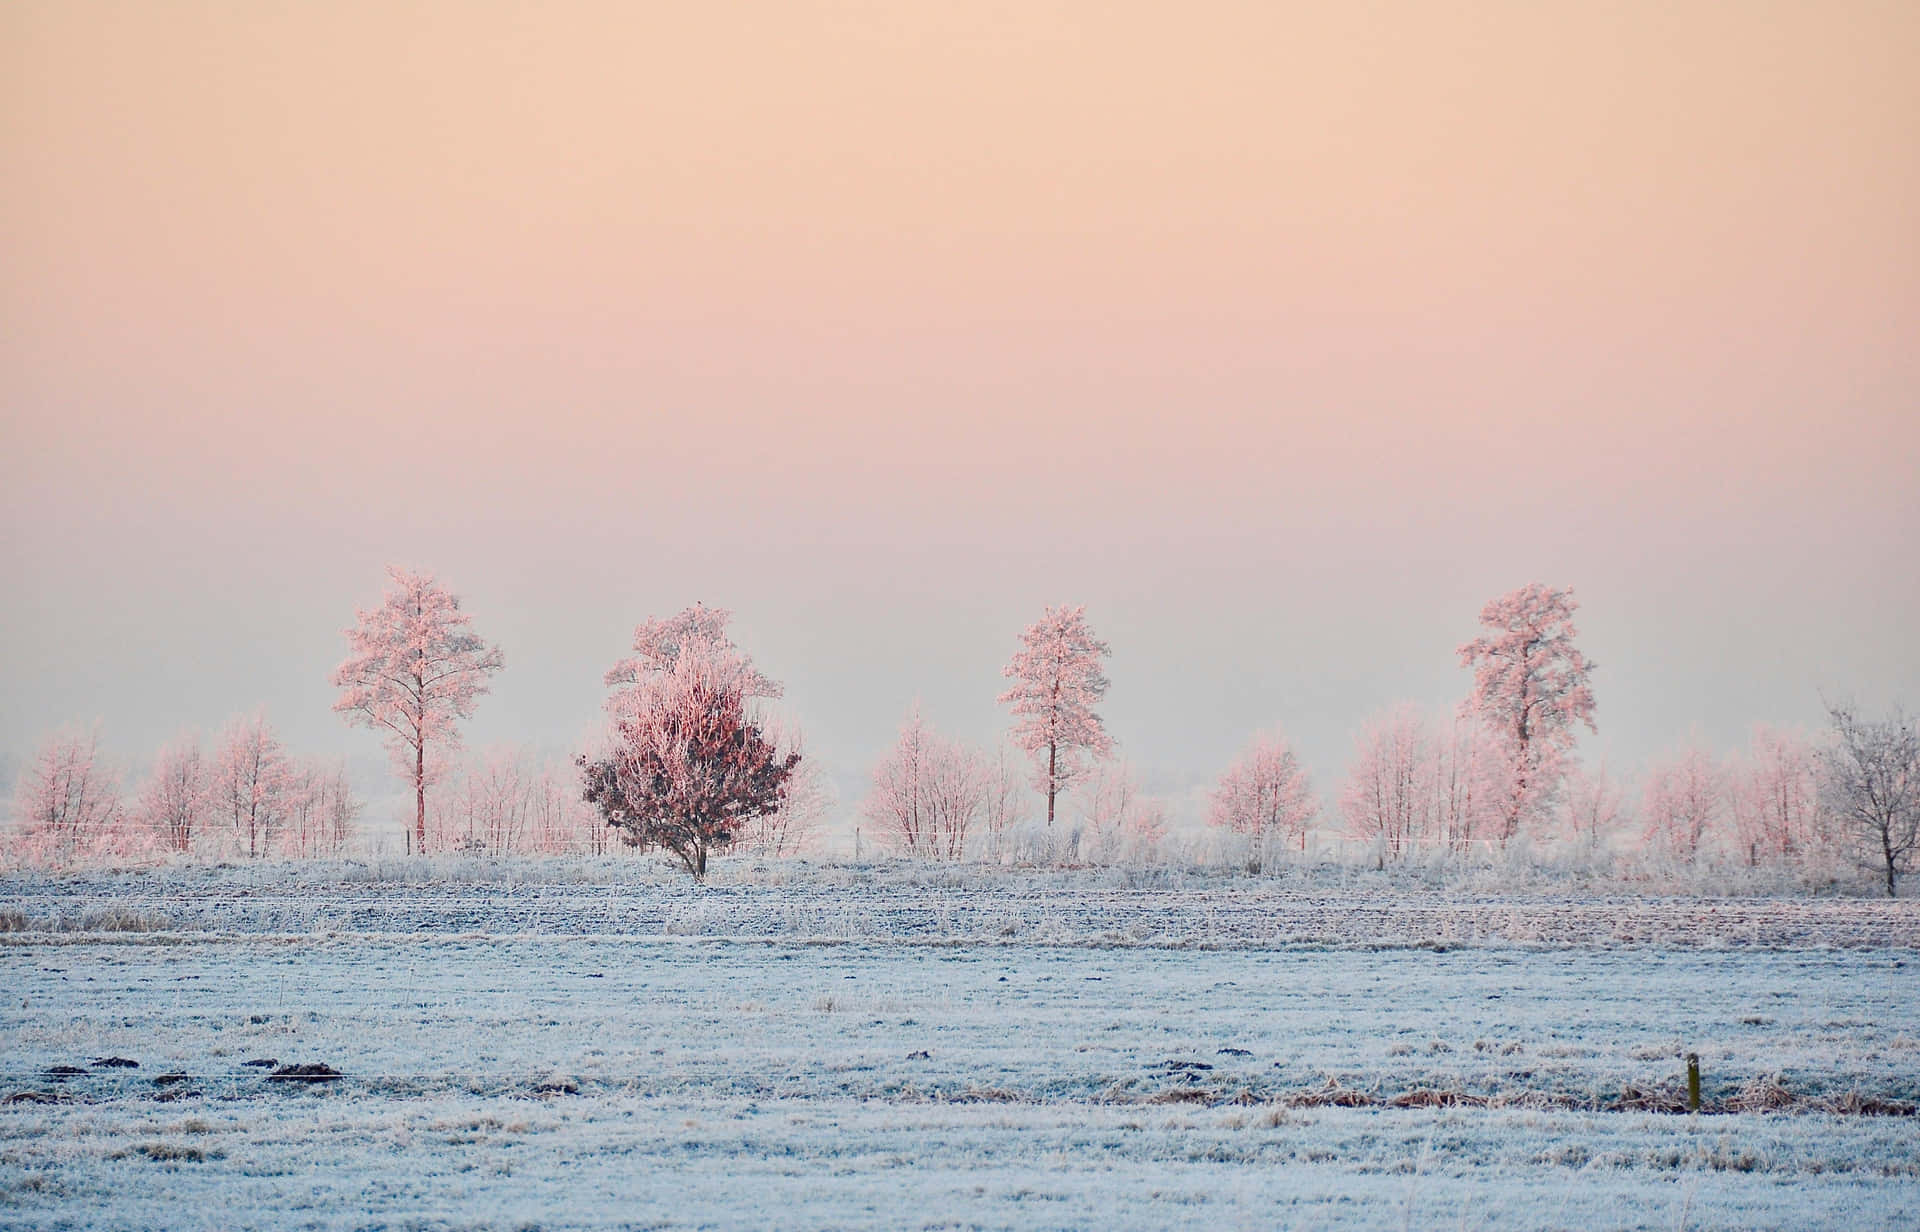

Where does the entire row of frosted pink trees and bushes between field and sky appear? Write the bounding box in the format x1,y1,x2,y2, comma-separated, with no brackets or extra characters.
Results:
8,568,1920,894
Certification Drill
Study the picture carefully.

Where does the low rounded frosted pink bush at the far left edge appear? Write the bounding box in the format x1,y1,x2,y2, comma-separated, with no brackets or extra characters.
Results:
13,723,125,865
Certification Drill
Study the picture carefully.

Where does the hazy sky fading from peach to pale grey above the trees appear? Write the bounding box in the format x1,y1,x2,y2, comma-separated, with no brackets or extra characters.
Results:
0,0,1920,836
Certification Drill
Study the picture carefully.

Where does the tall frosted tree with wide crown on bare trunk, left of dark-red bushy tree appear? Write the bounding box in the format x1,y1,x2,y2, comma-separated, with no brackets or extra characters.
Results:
332,568,505,852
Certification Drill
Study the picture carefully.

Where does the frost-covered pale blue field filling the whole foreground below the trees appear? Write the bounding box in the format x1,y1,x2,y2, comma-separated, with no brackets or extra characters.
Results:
0,862,1920,1228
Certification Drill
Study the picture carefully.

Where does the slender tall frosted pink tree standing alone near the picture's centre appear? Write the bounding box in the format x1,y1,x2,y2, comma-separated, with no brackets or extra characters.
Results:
1000,606,1114,829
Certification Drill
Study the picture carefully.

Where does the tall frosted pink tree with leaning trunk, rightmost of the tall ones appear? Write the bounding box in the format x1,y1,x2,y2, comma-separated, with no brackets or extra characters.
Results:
1459,581,1599,842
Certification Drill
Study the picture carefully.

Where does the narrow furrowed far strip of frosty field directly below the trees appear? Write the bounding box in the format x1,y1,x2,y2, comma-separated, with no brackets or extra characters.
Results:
0,860,1920,948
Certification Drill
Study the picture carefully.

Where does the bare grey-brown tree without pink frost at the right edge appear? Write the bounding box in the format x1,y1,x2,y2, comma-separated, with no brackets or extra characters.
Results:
1820,704,1920,898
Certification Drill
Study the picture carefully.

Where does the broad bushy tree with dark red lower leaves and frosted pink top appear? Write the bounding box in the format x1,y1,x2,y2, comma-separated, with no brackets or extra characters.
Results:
580,606,801,879
